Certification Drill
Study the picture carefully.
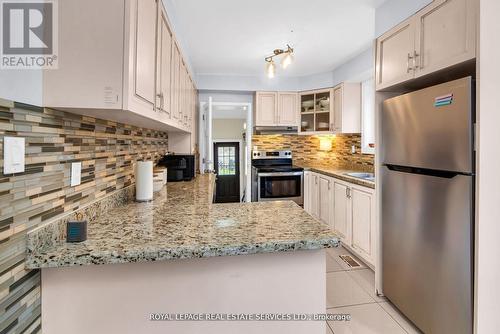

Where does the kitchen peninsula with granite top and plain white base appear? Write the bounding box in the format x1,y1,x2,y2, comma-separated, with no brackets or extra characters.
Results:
27,175,339,333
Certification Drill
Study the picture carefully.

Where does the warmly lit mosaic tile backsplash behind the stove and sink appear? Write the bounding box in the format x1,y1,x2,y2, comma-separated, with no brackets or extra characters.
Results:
252,134,374,172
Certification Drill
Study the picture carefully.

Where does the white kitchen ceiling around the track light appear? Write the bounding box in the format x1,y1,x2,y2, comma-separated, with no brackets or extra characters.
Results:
172,0,385,76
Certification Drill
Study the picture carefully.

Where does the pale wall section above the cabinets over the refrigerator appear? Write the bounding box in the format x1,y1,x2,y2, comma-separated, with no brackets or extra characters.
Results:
375,0,433,37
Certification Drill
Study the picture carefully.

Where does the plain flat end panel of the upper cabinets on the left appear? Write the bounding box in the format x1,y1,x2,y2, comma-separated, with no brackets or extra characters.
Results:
43,0,128,109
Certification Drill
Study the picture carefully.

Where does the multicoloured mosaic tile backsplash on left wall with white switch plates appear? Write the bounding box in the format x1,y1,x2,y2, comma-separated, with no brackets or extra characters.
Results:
0,100,168,334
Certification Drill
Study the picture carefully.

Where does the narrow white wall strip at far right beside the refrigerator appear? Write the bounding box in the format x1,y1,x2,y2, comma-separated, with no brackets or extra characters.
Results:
476,0,500,334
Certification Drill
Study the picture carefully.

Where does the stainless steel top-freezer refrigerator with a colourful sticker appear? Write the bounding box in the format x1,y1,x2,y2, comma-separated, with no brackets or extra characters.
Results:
381,78,475,334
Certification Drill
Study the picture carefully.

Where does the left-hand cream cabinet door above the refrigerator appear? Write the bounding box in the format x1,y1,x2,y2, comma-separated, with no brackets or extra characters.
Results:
376,19,415,89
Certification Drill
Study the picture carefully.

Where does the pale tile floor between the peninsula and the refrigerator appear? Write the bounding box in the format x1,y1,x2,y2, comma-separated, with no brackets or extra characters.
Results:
326,247,421,334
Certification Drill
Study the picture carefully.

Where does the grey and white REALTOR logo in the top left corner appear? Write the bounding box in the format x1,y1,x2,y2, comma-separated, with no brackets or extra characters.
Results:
0,0,57,69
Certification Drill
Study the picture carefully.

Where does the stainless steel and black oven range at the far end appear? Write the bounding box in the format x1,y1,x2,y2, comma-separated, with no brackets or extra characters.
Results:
252,151,304,205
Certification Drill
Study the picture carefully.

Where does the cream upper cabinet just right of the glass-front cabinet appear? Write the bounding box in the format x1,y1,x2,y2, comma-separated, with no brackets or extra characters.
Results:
333,83,361,133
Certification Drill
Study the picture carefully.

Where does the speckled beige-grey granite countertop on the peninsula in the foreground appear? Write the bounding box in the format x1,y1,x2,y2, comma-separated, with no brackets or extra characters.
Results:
27,175,339,269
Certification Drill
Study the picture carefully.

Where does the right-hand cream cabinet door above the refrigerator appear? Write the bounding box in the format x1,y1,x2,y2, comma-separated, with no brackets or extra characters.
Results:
415,0,476,75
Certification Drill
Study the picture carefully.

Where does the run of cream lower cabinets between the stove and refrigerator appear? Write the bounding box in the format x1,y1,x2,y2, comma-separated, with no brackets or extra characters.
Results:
304,171,376,266
